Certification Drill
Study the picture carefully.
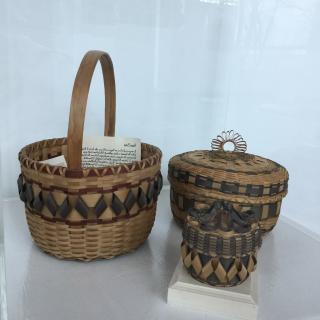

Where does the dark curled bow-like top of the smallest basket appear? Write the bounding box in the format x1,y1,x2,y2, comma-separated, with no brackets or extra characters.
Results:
189,201,258,233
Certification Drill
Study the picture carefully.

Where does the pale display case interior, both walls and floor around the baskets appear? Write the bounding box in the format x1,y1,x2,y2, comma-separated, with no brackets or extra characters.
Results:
0,0,320,320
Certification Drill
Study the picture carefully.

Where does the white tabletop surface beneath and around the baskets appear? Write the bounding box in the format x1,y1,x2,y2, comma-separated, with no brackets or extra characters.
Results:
4,190,320,320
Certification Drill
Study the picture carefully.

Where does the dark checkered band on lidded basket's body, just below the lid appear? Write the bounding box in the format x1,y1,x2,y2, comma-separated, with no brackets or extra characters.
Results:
170,187,282,220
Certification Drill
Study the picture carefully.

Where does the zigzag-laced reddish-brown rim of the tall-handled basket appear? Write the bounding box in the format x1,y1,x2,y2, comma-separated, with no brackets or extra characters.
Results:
18,137,162,178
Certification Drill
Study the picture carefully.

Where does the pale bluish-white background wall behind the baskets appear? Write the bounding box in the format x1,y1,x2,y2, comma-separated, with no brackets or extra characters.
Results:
0,0,320,231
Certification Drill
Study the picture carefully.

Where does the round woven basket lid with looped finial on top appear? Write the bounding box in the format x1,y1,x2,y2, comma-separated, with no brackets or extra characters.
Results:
169,131,289,196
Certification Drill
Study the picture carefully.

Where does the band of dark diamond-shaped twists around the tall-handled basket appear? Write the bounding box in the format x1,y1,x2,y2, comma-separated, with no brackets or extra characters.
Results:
18,172,162,223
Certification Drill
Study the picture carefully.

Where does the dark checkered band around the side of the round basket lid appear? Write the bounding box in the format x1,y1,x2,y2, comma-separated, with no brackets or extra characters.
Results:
168,166,288,197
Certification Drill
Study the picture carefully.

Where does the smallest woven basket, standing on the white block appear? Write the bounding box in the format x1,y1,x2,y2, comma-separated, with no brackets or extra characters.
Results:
181,201,261,287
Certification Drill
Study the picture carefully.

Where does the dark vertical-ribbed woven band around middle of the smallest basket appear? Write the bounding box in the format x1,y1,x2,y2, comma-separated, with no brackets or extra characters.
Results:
182,222,262,257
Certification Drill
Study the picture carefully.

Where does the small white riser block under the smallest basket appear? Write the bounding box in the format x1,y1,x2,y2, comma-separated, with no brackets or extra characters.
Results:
167,260,258,320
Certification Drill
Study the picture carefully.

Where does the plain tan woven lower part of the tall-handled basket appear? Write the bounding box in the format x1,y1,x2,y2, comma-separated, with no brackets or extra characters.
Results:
26,206,156,261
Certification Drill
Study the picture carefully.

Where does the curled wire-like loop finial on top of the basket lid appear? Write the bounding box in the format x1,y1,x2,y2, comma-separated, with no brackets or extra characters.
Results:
211,130,247,152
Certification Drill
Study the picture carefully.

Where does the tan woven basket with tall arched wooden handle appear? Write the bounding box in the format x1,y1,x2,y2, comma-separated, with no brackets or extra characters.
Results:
18,51,162,261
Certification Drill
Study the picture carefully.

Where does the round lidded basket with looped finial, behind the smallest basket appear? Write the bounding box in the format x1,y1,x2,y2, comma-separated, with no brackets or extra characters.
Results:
168,131,289,232
